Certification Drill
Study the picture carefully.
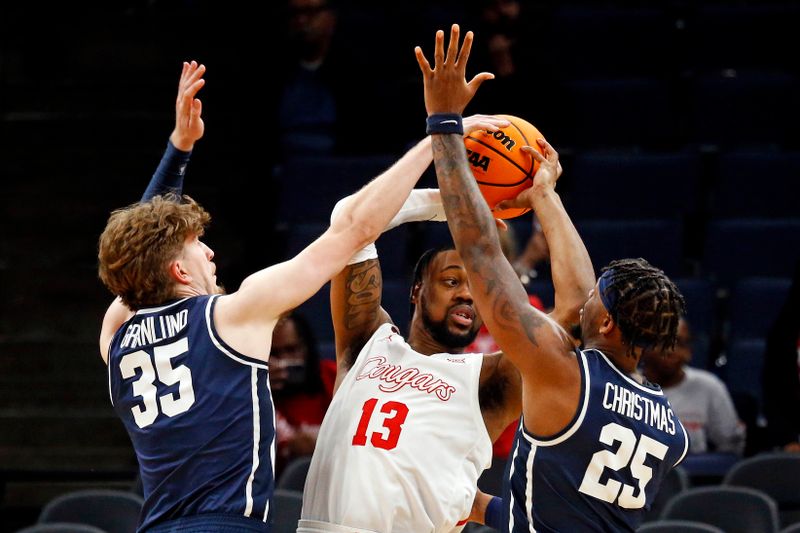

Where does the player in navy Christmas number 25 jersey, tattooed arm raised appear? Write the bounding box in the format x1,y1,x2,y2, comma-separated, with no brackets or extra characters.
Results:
416,26,688,533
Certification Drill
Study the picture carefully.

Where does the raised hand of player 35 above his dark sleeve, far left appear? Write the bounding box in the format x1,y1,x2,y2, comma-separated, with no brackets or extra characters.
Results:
169,61,206,152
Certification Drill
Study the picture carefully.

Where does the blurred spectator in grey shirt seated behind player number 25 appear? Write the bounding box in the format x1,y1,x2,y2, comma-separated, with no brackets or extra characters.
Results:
641,319,746,456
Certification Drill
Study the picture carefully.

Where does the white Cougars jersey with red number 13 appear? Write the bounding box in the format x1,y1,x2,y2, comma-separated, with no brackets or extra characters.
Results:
298,324,492,533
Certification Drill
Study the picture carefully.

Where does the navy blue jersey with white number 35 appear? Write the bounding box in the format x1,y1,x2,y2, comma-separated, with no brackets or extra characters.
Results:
108,296,275,531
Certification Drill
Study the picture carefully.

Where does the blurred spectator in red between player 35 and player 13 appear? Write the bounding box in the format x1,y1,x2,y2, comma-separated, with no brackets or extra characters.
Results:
269,312,336,471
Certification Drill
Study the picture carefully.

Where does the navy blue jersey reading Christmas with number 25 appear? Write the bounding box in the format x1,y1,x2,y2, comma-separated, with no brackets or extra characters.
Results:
503,350,689,533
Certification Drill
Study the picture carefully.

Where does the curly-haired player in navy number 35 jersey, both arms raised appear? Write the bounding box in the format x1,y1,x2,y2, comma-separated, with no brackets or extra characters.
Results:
99,62,438,533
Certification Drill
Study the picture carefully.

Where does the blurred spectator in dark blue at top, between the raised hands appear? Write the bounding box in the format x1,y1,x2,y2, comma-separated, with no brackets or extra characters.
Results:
278,0,338,156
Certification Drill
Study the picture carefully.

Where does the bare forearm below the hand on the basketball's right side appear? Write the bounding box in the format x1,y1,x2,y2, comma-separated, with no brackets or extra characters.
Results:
533,188,595,327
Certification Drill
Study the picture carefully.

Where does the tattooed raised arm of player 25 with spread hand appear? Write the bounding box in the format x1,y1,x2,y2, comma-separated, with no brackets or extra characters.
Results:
416,26,581,435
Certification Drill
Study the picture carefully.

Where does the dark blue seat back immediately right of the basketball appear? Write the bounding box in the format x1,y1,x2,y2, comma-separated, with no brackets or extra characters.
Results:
565,152,700,220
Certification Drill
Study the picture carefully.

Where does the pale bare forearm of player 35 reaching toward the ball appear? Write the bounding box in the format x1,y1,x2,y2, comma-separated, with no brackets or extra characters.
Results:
331,138,431,242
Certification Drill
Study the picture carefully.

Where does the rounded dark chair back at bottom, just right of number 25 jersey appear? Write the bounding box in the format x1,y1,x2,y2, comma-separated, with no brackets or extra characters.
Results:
661,486,778,533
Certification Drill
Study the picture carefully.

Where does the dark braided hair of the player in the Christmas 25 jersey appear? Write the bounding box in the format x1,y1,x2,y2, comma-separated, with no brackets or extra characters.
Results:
603,258,686,354
